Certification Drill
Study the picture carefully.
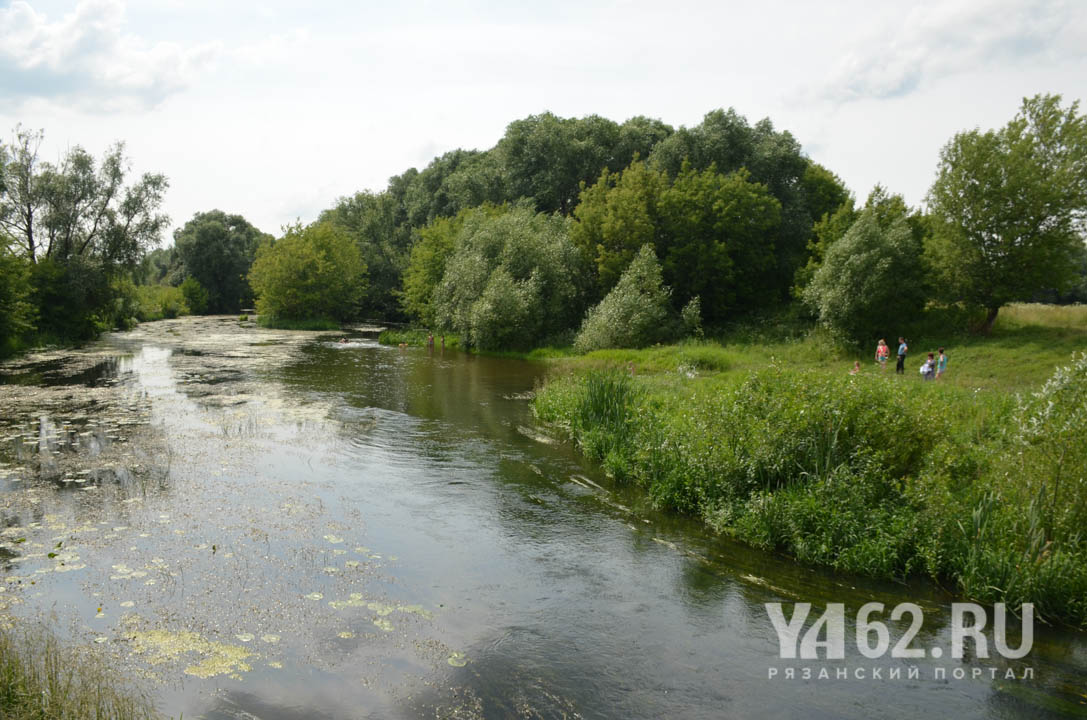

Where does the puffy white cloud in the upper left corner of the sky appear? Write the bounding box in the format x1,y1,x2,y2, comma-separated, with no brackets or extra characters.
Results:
0,0,217,111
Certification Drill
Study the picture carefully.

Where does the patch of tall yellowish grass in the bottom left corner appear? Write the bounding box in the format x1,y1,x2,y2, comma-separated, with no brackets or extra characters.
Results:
0,628,159,720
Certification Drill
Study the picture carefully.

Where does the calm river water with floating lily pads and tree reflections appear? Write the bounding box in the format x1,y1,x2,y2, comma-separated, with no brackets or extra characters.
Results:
0,318,1087,720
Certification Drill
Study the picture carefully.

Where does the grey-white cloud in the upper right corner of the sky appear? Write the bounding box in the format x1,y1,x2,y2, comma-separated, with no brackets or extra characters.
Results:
816,0,1087,102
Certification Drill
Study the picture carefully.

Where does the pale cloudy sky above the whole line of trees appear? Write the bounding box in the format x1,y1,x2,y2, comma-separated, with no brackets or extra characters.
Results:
0,0,1087,241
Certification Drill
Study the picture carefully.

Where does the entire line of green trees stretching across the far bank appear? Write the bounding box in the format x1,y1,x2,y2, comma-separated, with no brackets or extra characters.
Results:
0,96,1087,349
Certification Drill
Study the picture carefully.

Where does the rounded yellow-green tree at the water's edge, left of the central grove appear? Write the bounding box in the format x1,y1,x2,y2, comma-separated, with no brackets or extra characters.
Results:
248,222,366,323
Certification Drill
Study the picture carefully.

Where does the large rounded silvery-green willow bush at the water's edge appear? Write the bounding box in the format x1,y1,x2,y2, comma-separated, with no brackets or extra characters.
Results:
433,207,588,350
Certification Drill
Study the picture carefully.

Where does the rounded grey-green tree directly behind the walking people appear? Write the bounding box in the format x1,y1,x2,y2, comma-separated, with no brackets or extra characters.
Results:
802,208,925,342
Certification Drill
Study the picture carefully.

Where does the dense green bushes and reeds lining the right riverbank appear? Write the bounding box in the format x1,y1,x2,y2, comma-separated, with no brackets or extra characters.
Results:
535,355,1087,629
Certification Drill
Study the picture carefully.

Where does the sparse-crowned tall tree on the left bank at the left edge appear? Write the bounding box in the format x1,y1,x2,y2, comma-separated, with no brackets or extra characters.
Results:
0,127,170,338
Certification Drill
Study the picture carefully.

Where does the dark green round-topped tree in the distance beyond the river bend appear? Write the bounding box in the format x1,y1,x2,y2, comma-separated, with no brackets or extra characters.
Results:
174,210,271,313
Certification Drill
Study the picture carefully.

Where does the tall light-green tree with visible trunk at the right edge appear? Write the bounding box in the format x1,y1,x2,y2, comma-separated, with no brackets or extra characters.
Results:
927,95,1087,332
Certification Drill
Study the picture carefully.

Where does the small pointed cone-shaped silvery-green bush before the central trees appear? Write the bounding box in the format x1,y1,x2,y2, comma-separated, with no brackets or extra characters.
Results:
574,245,671,352
